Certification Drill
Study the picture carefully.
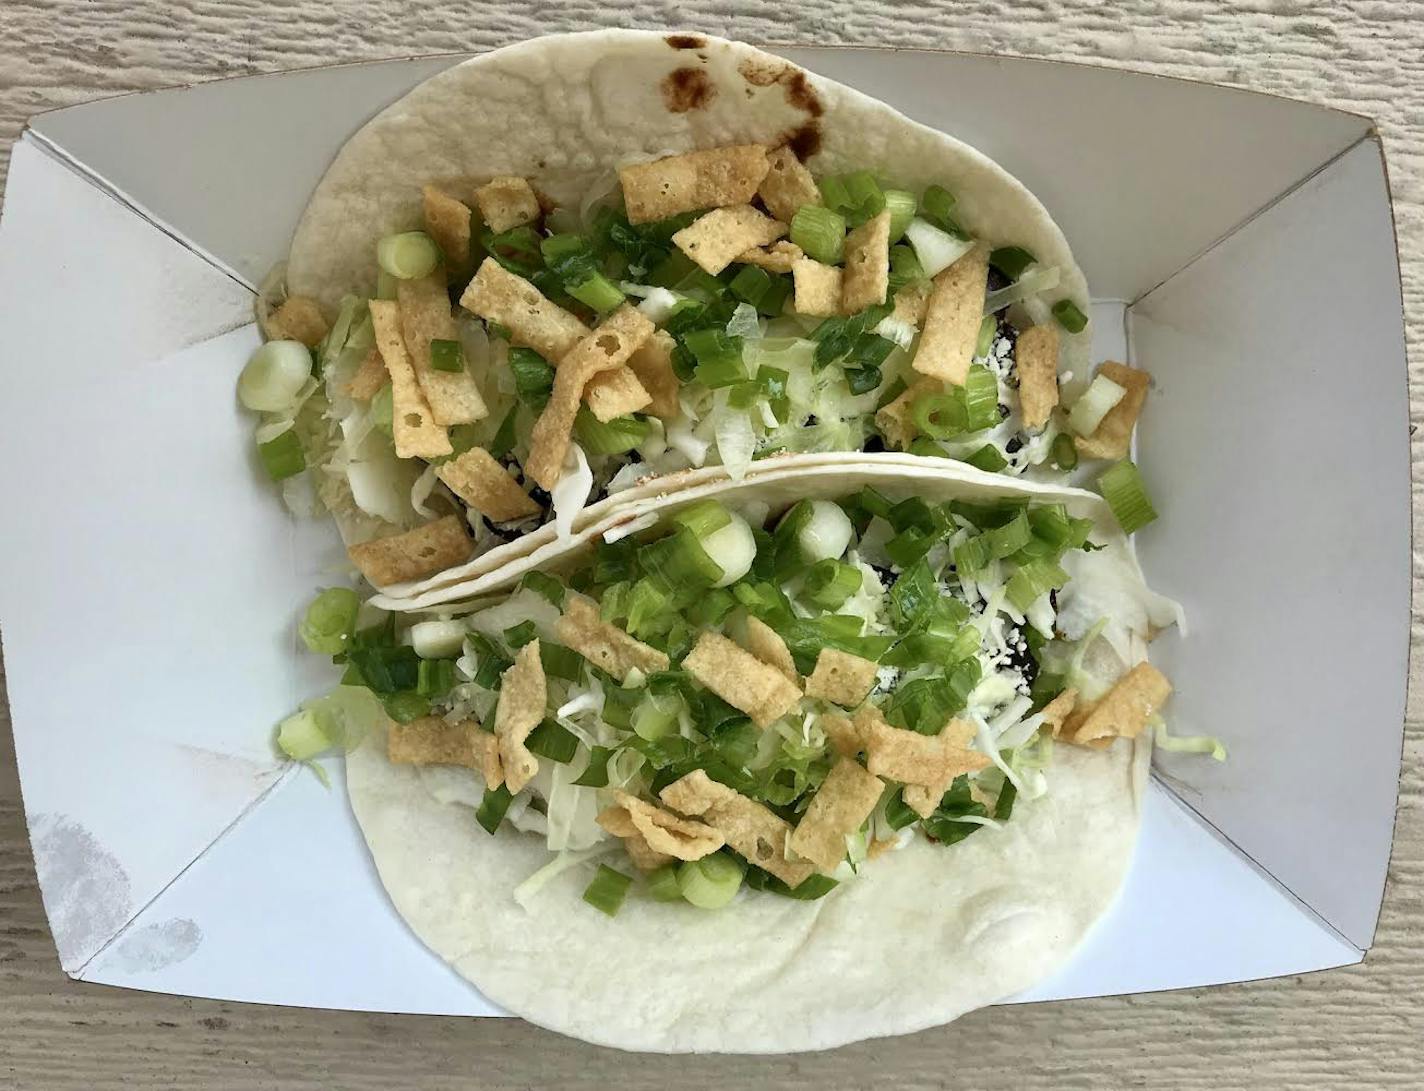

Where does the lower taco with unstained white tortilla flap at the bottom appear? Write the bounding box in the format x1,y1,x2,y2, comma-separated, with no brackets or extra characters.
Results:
274,464,1190,1053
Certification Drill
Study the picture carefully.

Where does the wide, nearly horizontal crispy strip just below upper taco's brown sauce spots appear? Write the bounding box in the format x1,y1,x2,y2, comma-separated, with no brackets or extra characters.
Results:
618,144,770,224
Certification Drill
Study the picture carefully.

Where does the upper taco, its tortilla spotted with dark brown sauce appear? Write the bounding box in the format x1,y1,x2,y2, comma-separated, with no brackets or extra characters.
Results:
242,31,1146,594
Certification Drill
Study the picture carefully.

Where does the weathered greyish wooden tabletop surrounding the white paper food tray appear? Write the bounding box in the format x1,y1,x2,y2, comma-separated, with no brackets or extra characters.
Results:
0,0,1424,1091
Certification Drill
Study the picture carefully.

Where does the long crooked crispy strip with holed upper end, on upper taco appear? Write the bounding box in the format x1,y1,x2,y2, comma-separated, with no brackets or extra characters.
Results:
524,303,655,489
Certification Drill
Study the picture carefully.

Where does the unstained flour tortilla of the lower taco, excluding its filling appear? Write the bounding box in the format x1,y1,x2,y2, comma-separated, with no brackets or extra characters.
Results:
347,460,1149,1053
